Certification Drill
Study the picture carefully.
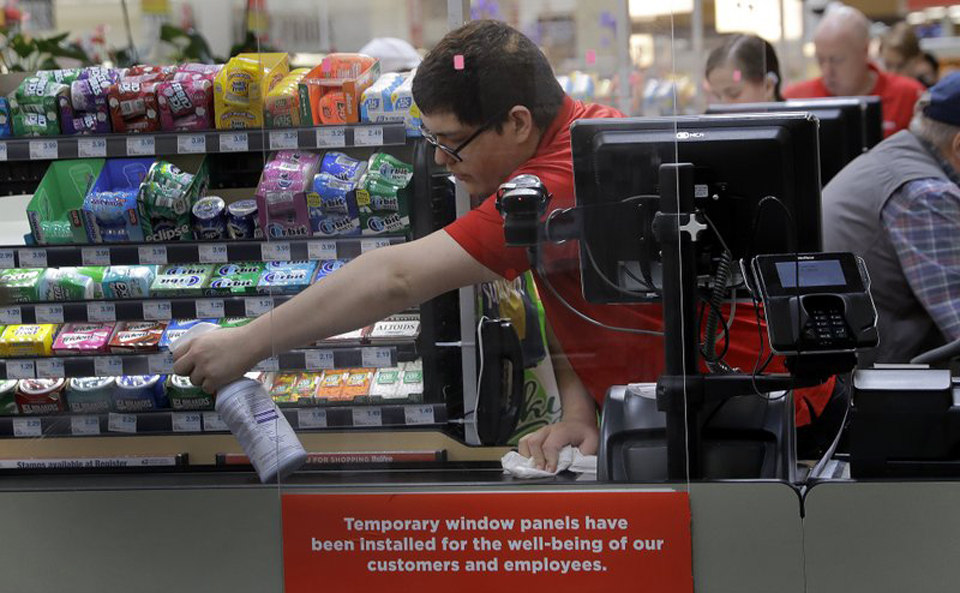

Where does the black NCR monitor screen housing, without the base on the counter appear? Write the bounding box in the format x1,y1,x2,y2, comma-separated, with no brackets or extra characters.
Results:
571,113,821,303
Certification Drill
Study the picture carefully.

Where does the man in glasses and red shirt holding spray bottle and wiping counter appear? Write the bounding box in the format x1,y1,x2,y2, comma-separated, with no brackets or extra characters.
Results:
174,21,825,469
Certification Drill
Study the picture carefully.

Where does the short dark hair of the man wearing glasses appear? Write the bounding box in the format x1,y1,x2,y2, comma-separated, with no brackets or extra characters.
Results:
413,20,564,131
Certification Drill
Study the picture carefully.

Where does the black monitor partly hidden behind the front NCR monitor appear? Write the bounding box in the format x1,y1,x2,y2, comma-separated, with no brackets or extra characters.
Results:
707,97,883,185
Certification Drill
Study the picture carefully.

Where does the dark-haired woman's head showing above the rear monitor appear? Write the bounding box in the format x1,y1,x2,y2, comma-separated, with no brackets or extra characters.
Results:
704,34,783,103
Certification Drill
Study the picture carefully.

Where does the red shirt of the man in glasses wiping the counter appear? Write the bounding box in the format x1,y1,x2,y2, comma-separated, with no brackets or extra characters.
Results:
445,97,833,425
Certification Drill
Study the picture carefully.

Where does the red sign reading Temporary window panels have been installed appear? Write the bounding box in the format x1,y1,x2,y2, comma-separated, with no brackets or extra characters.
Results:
283,491,693,593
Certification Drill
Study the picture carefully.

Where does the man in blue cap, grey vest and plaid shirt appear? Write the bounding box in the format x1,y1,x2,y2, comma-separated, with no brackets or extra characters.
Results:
823,73,960,367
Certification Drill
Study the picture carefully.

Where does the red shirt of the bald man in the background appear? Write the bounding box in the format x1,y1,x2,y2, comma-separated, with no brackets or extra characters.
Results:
783,64,925,138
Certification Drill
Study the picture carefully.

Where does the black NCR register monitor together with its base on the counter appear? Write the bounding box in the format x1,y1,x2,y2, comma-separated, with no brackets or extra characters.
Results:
571,114,821,482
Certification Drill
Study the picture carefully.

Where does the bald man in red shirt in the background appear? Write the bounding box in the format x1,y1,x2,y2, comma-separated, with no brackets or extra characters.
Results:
783,6,924,136
